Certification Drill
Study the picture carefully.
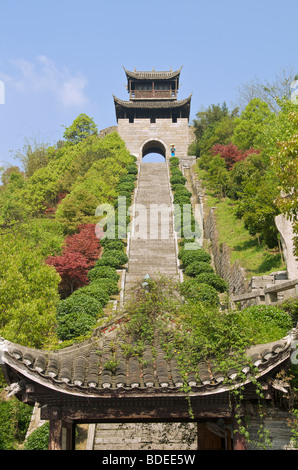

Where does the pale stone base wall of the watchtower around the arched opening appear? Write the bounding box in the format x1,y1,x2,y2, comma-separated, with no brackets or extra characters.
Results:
118,118,193,160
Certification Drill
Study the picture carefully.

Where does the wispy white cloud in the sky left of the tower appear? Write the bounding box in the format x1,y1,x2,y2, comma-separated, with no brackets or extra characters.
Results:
0,55,88,107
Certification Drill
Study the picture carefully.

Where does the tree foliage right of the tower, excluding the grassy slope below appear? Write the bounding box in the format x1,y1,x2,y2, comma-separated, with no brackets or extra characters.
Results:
194,86,298,252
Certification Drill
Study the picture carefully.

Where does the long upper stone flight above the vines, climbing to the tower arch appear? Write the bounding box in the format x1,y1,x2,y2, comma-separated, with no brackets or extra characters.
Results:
125,163,178,295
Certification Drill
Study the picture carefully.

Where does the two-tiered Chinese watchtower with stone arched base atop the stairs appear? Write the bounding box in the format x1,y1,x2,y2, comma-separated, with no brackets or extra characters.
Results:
114,68,193,160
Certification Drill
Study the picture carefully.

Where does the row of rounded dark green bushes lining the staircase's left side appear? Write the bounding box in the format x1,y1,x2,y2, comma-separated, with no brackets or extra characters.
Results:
57,162,138,341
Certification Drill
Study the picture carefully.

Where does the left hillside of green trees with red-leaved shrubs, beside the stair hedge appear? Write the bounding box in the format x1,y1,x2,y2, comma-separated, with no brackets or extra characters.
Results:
0,115,134,348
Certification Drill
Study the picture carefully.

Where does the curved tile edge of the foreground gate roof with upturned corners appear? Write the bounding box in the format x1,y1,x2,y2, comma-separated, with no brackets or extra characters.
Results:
0,329,297,399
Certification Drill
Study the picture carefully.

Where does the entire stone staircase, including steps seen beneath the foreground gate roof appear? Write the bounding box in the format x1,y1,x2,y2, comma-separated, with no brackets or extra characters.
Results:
89,162,179,450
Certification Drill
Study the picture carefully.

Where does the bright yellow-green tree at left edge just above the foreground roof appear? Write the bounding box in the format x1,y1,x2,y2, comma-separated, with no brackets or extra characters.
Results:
0,234,60,348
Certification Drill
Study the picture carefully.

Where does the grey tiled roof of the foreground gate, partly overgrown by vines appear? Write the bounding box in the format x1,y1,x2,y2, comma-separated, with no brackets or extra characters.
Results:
0,317,297,397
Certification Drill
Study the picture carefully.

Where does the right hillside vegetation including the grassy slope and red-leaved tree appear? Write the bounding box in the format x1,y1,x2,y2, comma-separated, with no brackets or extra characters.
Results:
189,98,298,276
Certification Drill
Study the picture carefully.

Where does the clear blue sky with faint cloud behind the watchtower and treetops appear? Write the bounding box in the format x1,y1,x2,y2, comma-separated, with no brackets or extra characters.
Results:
0,0,298,164
